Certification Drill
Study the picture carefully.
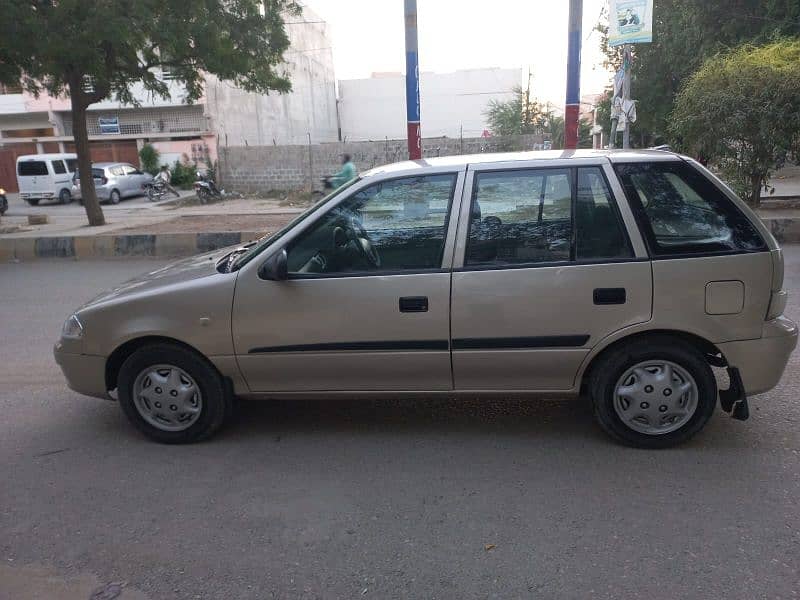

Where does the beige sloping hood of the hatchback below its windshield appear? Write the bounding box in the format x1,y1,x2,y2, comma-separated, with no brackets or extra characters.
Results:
78,248,231,311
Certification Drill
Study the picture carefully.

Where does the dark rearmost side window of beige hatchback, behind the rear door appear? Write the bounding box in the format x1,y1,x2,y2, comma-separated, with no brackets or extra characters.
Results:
615,161,766,256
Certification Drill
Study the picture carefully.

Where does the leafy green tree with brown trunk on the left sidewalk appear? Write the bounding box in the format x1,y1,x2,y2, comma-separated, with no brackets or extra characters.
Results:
0,0,300,225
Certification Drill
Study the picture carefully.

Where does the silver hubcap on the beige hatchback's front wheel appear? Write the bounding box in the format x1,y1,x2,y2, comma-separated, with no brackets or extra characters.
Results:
133,365,203,431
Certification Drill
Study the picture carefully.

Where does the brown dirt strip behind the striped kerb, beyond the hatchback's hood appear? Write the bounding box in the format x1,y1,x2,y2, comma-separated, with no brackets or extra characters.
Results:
115,213,296,234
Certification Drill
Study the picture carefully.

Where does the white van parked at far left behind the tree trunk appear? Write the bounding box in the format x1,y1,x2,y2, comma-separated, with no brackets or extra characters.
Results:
17,154,78,206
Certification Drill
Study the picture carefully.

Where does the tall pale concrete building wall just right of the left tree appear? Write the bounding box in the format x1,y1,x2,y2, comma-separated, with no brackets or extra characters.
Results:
206,3,339,146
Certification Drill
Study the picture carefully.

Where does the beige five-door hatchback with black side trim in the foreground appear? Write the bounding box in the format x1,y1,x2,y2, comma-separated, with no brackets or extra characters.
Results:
55,151,797,448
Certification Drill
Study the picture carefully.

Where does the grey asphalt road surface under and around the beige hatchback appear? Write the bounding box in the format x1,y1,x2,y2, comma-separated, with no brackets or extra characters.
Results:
0,253,800,600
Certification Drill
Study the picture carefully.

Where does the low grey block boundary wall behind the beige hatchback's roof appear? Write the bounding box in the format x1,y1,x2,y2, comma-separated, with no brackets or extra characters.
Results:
219,135,542,192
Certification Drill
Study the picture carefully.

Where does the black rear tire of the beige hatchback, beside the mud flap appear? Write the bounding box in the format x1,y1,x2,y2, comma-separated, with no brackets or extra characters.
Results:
589,336,717,449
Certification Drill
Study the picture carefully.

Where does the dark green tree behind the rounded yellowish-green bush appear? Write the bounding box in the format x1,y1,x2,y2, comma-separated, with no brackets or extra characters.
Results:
600,0,800,145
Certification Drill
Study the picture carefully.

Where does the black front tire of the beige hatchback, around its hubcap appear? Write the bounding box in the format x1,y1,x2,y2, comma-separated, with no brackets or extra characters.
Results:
117,343,232,444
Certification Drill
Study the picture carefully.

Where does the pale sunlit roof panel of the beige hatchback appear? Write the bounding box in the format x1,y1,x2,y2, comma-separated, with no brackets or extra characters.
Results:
363,150,680,176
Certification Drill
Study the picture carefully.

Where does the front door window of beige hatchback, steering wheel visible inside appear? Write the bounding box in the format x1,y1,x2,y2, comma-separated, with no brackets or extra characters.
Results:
287,174,456,278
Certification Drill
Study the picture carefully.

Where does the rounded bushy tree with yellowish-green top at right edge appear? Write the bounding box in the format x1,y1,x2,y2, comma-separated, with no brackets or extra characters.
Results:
671,40,800,206
